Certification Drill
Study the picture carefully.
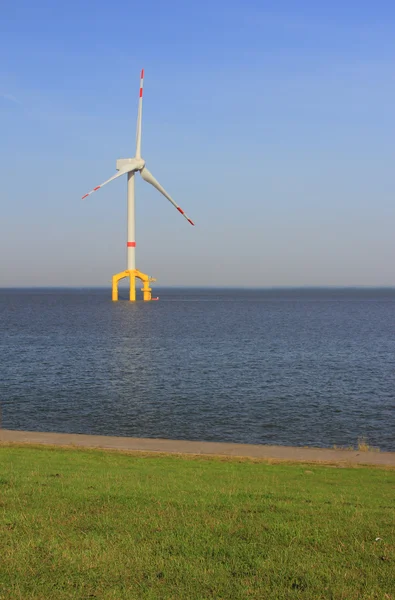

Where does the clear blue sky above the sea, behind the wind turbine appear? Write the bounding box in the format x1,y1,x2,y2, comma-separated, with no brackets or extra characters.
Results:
0,0,395,287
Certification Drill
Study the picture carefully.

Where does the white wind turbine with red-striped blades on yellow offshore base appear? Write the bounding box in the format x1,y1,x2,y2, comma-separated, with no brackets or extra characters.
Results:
82,69,194,301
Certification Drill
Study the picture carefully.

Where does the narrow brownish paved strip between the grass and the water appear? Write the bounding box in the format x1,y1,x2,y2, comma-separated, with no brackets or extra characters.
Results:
0,429,395,467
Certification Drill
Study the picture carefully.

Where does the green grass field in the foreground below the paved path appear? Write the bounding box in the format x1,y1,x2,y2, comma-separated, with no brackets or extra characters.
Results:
0,446,395,600
